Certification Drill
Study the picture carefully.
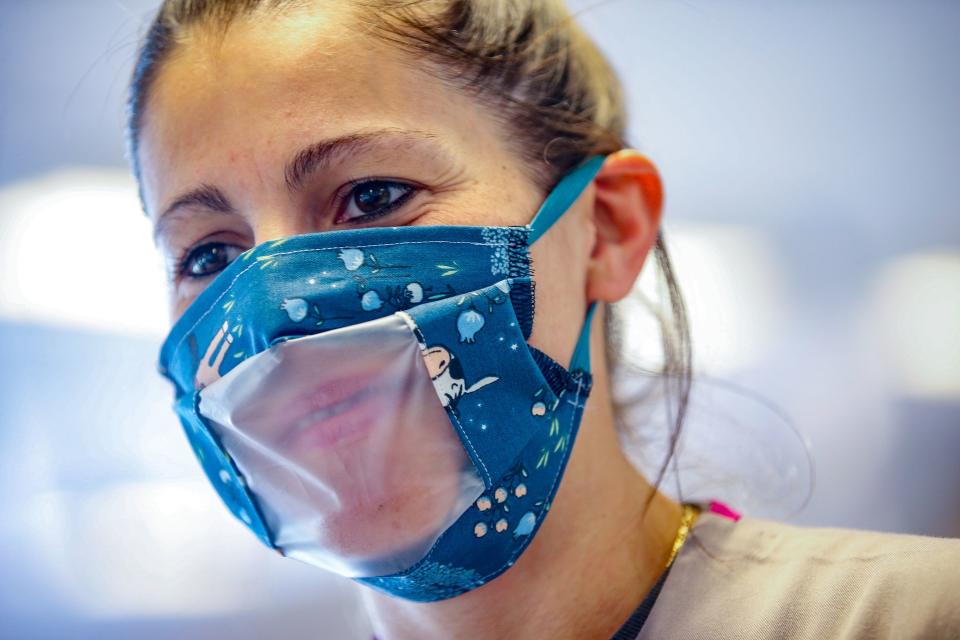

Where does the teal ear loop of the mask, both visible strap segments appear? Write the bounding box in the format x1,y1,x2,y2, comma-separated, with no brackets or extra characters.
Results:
527,156,605,373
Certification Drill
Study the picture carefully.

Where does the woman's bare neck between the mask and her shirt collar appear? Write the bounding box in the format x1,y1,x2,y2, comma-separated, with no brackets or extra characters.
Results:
362,358,681,640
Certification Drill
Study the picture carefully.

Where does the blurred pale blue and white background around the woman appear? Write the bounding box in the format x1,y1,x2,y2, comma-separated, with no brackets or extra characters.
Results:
0,0,960,638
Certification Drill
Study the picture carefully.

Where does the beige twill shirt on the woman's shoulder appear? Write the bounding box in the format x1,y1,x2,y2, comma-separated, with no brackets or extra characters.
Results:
638,513,960,640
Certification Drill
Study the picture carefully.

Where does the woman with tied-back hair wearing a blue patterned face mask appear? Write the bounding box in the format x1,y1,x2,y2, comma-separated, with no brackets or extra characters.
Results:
129,0,960,638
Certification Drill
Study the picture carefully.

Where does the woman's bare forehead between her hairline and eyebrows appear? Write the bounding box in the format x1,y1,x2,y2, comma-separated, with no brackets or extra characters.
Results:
140,6,504,216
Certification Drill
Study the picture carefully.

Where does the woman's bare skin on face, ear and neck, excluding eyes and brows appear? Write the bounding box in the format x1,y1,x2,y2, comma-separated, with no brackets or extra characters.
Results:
140,4,680,638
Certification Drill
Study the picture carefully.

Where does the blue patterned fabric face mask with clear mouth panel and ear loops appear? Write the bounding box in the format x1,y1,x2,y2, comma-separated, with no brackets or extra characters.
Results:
160,157,603,601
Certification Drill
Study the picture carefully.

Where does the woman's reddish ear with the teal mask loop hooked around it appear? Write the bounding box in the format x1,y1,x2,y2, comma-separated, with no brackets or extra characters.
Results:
586,149,663,302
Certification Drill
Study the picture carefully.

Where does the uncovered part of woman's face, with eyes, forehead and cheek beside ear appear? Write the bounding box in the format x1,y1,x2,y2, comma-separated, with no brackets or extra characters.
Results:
140,3,589,362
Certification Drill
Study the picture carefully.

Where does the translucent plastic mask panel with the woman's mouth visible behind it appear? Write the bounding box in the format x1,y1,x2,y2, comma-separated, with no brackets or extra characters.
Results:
200,315,484,577
